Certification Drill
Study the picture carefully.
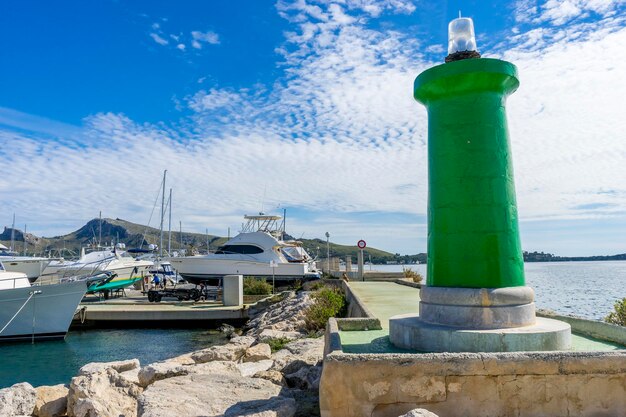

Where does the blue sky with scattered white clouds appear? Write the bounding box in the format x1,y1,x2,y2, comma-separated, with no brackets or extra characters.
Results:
0,0,626,255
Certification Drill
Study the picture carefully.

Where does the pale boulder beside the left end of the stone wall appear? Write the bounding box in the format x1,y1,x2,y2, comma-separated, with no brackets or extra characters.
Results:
272,337,324,374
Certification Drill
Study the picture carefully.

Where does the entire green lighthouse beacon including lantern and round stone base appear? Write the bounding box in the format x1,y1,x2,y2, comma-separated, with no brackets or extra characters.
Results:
390,17,571,352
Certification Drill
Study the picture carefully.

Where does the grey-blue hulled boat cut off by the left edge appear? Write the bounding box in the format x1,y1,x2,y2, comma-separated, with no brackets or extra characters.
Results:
0,262,87,342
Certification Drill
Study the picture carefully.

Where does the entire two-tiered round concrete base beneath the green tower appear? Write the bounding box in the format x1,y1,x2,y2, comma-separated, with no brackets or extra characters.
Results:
389,287,571,352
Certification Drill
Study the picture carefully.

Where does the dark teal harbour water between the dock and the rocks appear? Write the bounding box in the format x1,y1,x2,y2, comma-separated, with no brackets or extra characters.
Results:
0,329,226,388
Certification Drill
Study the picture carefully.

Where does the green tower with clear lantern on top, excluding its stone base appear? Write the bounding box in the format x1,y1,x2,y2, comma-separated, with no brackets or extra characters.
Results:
414,18,524,288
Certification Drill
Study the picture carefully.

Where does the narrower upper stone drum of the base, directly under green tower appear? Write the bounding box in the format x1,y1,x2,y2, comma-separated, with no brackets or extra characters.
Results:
420,286,535,330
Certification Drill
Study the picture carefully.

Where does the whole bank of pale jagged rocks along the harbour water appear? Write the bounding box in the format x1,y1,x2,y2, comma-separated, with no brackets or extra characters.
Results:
0,291,324,417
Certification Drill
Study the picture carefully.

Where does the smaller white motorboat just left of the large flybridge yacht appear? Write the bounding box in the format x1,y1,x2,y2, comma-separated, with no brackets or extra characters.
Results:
43,244,154,281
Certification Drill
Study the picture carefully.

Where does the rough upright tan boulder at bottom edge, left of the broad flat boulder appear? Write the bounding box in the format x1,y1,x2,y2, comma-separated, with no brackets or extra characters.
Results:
67,368,142,417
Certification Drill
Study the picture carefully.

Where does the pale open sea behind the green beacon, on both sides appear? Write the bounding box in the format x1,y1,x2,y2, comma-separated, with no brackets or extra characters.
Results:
365,261,626,320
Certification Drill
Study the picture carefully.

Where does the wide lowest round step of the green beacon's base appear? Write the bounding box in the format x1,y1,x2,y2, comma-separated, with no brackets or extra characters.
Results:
389,314,571,352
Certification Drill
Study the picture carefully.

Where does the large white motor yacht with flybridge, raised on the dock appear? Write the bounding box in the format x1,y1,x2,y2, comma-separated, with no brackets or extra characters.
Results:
169,213,320,283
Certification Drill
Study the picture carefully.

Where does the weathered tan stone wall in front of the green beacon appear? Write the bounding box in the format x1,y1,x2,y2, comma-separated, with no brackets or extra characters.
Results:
320,319,626,417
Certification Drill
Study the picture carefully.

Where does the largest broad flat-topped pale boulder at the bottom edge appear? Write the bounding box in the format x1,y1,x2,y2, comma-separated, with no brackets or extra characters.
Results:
139,374,295,417
